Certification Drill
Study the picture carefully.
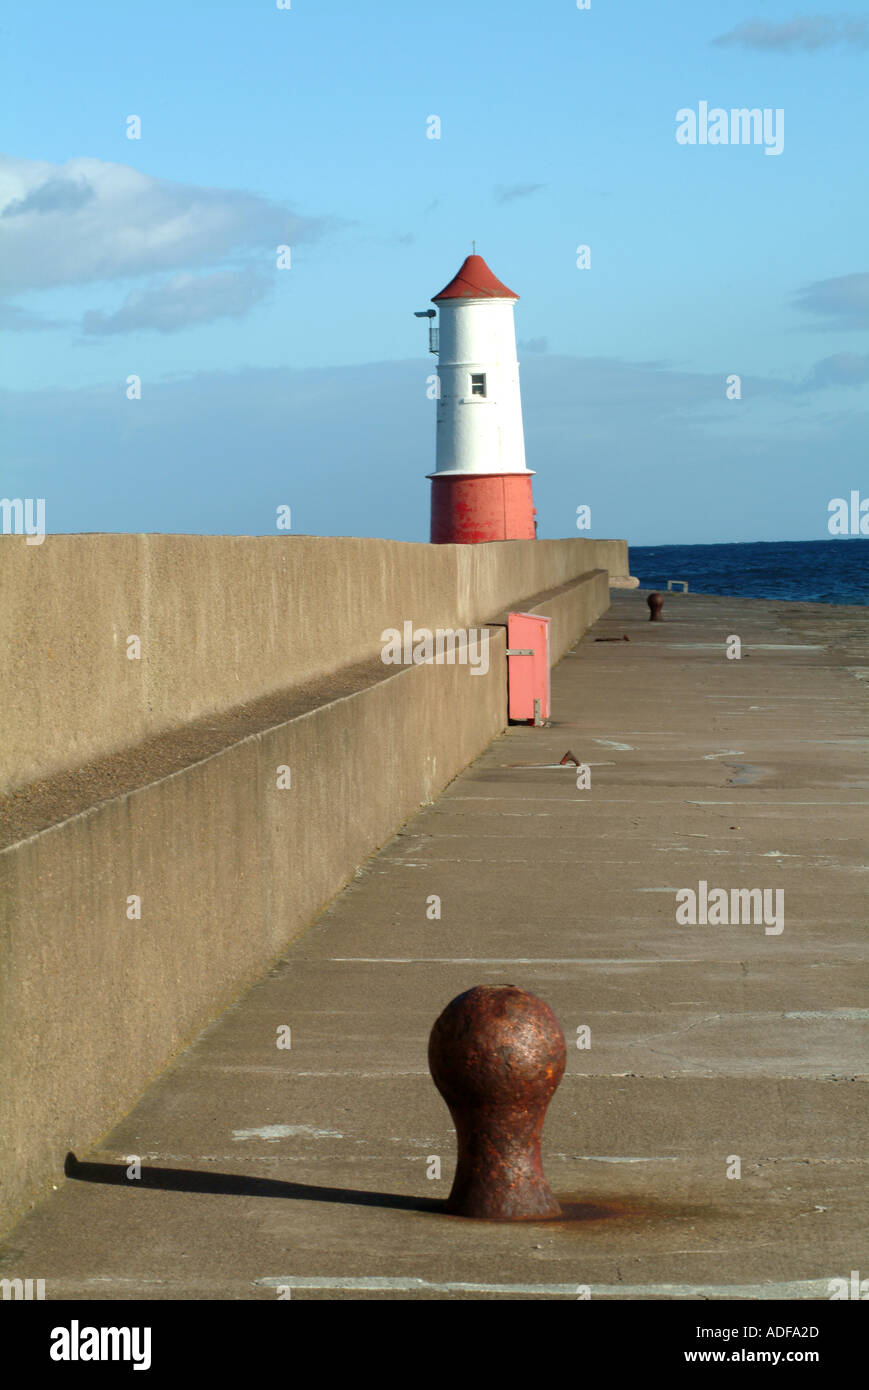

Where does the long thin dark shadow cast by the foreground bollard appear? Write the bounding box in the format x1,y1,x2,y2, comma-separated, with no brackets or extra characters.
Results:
64,1154,444,1212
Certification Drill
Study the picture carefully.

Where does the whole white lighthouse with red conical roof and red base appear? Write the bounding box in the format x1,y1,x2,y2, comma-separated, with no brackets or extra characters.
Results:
419,256,537,545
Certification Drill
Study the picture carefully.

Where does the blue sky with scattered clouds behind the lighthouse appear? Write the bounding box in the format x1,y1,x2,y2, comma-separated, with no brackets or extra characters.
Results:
0,0,869,545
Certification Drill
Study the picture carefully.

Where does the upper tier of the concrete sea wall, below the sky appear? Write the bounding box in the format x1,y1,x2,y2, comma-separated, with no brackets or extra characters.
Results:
0,535,627,792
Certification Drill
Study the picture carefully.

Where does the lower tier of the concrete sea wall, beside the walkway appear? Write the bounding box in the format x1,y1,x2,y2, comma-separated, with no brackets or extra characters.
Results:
0,564,609,1230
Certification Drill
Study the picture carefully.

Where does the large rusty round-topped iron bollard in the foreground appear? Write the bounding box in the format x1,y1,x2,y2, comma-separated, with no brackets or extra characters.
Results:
428,984,567,1220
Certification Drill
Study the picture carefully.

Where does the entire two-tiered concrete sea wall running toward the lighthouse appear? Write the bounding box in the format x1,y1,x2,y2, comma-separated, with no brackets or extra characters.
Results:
0,535,627,1229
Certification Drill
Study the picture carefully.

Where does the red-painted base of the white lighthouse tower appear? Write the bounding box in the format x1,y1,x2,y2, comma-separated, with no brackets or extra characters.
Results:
430,473,537,545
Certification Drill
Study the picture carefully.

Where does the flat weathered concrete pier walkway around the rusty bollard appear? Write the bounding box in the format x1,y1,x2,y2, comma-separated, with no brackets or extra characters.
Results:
0,592,869,1300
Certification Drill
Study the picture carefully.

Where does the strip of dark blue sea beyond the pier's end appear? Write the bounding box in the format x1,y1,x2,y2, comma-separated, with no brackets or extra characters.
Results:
630,537,869,605
